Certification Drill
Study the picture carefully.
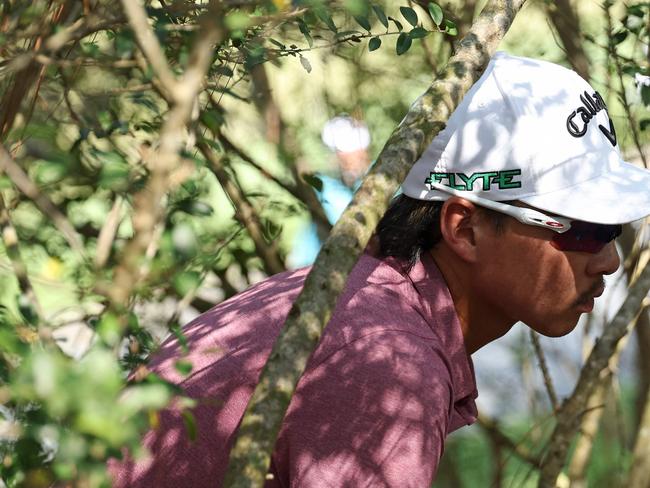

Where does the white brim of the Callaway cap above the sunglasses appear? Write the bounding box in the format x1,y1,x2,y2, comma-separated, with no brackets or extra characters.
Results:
519,161,650,224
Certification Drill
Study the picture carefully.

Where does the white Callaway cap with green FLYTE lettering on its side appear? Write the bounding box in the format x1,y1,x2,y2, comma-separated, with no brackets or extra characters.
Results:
402,52,650,224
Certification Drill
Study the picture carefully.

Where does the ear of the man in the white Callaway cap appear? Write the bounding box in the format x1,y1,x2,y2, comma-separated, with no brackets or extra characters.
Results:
440,197,480,262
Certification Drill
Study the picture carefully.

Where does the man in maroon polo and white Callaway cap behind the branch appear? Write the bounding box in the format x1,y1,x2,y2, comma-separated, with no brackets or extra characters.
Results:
111,53,650,487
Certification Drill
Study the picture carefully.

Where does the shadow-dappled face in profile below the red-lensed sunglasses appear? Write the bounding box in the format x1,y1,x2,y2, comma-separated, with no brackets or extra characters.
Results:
475,217,620,336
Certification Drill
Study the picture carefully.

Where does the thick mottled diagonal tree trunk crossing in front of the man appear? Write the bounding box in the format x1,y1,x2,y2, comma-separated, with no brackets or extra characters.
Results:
226,0,525,487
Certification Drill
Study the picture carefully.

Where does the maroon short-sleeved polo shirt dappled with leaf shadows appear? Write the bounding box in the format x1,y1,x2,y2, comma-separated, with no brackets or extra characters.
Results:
111,254,477,488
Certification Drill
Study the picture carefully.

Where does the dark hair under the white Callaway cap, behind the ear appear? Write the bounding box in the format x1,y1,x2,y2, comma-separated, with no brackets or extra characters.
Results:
377,194,510,269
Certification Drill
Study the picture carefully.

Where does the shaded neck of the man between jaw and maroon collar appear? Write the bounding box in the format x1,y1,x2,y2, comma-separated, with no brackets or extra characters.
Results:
431,246,515,354
